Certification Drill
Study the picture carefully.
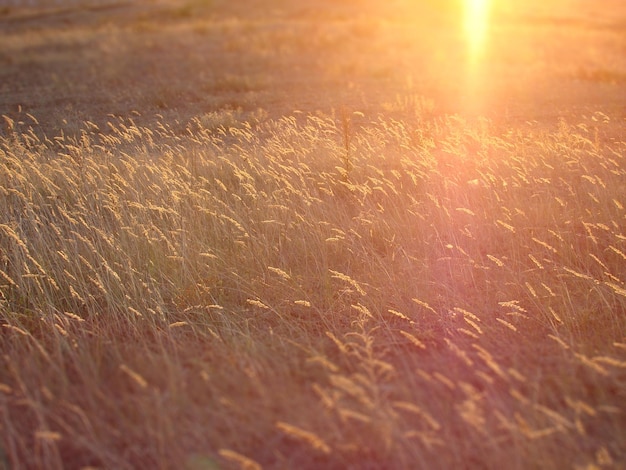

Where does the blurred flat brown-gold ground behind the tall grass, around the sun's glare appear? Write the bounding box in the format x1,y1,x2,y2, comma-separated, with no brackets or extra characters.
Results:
0,0,626,137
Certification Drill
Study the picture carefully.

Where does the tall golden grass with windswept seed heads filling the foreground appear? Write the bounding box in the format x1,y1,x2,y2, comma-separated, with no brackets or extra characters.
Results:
0,2,626,470
